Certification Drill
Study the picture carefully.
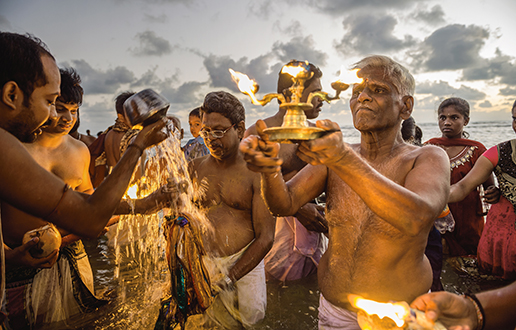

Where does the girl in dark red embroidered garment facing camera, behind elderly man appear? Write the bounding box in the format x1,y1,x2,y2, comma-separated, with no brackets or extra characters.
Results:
426,97,494,256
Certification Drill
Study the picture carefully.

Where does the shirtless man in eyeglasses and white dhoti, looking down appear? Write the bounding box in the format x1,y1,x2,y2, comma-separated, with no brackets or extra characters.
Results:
187,91,275,329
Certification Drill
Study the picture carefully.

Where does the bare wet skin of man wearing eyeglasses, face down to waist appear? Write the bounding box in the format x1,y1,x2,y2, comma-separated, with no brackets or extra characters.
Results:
190,113,275,280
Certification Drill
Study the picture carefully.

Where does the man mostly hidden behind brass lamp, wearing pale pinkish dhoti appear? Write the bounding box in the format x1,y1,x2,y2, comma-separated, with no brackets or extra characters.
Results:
244,60,328,282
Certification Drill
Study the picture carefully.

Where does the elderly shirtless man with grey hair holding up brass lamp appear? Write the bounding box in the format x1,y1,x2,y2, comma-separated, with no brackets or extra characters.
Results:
241,56,449,329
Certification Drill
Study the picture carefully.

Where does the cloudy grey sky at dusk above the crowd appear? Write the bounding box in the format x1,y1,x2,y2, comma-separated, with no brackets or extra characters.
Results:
0,0,516,137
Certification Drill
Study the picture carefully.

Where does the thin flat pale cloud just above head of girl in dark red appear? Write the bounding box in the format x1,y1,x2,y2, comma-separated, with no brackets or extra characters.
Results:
416,80,486,101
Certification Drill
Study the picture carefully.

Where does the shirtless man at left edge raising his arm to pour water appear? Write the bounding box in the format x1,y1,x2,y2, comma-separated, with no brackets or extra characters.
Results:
0,32,166,322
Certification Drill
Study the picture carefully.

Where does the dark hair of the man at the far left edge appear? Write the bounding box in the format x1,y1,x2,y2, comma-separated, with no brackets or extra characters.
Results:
0,32,55,106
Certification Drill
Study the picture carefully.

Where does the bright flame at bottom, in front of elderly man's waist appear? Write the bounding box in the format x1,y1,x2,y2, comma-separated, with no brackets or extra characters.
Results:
348,294,410,327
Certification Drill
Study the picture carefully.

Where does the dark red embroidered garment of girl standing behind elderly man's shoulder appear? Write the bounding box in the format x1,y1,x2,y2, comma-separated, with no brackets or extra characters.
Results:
425,138,486,256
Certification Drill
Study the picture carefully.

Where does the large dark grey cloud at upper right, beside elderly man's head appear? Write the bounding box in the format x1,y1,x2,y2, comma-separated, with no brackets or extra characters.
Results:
410,24,489,71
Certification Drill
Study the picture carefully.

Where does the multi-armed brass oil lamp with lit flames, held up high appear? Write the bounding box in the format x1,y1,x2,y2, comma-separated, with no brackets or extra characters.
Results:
229,61,359,143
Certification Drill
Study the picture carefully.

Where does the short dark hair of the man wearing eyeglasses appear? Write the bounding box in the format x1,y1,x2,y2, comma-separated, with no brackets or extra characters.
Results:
200,91,245,125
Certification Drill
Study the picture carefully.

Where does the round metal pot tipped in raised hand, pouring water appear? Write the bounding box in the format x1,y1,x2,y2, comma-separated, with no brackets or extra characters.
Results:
124,88,170,128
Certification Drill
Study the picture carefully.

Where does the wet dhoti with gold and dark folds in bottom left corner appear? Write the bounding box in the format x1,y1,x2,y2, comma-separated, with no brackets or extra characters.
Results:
5,241,107,329
